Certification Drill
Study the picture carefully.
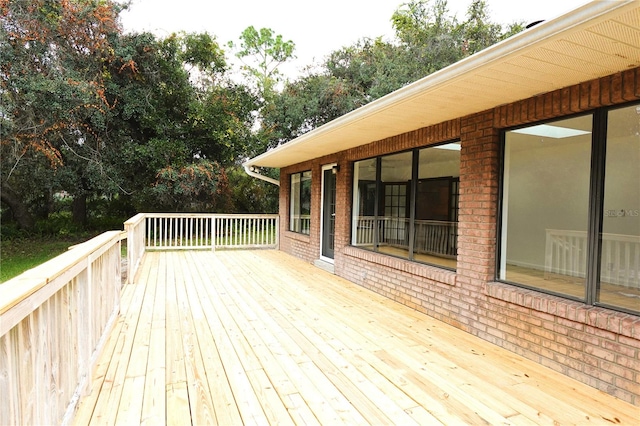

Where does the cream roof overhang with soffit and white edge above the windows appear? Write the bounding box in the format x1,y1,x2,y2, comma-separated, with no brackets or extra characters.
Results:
245,0,640,167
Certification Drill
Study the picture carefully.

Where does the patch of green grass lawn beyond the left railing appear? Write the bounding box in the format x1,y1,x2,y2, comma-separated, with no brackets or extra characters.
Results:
0,237,87,283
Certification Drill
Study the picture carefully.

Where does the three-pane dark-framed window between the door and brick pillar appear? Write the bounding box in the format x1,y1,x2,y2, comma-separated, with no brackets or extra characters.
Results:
351,142,460,269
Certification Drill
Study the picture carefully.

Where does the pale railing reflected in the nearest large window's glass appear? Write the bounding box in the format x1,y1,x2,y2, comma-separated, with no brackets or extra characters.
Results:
544,229,640,288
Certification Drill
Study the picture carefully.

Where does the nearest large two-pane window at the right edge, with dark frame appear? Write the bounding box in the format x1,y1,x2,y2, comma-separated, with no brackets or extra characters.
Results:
498,105,640,312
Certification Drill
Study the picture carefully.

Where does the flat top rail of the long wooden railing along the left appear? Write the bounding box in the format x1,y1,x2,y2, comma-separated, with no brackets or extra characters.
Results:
0,231,121,315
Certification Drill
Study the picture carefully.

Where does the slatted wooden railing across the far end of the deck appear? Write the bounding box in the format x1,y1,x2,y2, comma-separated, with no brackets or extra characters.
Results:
125,213,279,282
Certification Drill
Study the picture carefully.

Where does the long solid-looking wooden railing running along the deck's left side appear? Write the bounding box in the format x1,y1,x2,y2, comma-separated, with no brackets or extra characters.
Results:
0,231,122,425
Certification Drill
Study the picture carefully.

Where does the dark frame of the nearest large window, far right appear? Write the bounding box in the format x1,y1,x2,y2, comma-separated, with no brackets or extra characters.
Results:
494,101,640,315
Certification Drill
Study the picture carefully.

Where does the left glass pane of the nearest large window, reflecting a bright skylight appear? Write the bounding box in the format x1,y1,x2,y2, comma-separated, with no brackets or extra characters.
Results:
500,115,592,298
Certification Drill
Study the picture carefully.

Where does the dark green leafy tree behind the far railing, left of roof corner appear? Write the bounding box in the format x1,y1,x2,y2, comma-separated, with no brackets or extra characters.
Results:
102,33,257,210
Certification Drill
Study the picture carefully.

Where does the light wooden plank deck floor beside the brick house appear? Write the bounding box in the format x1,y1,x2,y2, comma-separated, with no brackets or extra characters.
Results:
75,250,639,425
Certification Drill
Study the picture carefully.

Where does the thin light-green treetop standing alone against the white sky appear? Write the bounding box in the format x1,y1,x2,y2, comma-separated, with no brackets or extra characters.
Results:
229,26,295,102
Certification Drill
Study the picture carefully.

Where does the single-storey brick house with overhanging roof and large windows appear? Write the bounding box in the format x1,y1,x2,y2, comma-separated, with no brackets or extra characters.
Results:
245,0,640,405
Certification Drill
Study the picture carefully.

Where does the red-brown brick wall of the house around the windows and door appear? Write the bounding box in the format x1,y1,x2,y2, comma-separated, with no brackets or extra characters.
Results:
280,68,640,405
